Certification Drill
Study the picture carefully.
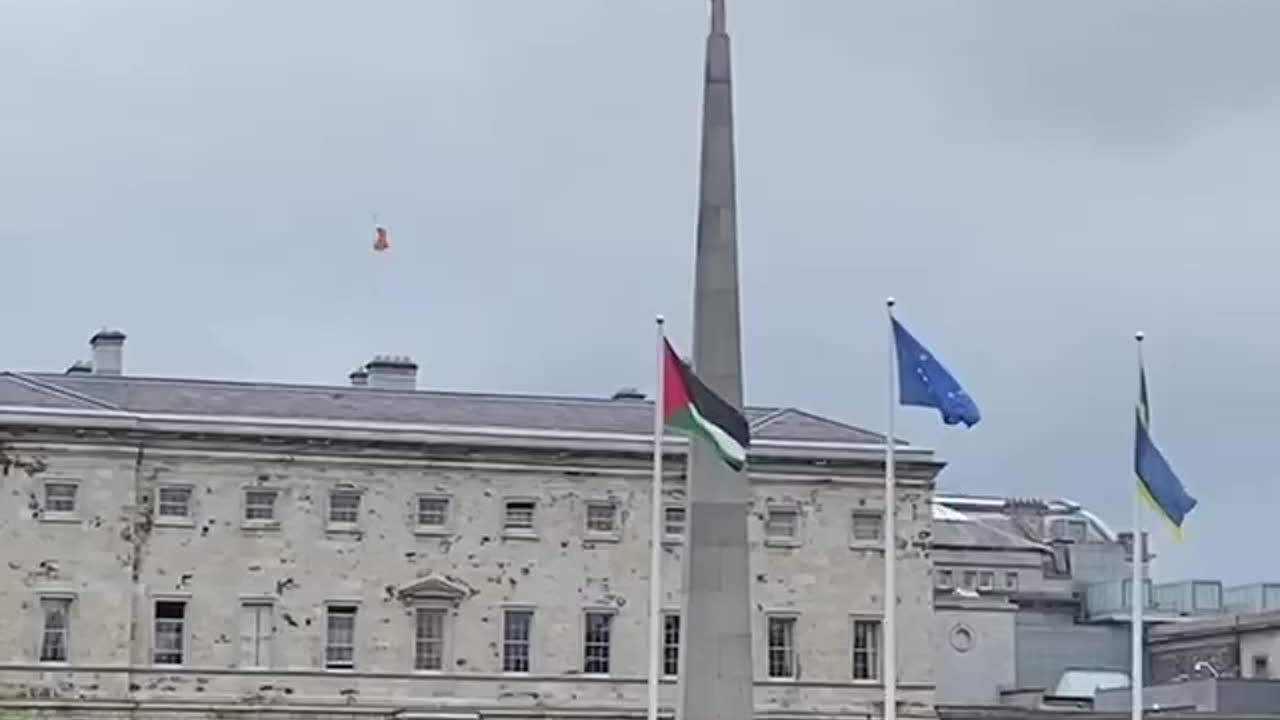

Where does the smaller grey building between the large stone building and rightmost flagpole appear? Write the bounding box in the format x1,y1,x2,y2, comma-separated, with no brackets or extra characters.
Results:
933,495,1132,706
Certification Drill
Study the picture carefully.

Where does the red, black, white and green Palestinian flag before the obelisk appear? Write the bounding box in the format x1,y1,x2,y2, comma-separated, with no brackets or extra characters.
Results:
662,340,751,470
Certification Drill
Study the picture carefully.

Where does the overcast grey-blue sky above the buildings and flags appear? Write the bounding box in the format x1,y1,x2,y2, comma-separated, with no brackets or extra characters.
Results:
0,0,1280,582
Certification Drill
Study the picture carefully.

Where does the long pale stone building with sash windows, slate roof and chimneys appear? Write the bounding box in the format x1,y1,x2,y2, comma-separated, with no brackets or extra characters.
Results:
0,333,941,719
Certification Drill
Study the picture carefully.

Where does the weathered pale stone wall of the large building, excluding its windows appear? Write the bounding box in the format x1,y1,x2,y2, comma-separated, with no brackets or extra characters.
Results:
0,442,933,714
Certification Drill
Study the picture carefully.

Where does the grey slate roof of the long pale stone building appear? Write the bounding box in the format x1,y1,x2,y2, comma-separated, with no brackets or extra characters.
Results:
0,373,901,443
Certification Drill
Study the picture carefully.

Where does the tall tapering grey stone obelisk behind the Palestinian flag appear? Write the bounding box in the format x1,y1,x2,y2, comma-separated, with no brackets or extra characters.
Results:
677,0,754,720
